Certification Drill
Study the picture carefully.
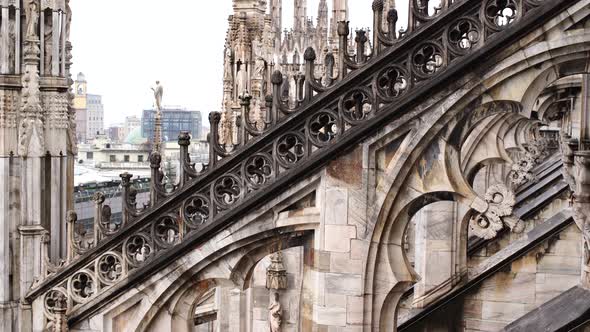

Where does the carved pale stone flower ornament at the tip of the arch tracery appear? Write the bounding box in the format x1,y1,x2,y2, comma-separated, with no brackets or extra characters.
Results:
469,184,525,240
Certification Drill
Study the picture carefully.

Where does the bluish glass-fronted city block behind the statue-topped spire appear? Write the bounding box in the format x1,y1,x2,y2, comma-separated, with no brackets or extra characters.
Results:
141,108,202,142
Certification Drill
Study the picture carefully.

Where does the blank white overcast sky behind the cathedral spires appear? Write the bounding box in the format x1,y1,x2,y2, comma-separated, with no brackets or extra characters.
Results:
71,0,407,126
